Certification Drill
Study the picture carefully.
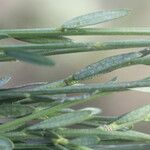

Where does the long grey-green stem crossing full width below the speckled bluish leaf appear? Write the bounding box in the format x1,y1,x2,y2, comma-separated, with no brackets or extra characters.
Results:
0,80,150,97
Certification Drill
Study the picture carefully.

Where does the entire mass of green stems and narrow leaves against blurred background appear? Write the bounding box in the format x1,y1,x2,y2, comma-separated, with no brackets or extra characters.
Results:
0,9,150,150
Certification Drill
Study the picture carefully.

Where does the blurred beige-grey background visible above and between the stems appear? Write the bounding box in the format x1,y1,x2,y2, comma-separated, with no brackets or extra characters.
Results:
0,0,150,133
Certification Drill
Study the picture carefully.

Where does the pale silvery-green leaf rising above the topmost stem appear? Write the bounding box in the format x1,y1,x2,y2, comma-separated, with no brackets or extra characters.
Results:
62,9,129,28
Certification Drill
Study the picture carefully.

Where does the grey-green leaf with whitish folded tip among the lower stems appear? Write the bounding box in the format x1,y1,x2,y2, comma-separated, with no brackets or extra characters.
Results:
28,108,99,130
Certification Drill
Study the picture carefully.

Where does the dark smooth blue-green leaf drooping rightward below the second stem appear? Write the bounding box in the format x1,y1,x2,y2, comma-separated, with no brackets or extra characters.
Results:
5,50,54,66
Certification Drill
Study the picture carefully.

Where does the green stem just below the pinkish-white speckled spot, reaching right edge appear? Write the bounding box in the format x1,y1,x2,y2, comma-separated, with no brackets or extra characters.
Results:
55,128,150,141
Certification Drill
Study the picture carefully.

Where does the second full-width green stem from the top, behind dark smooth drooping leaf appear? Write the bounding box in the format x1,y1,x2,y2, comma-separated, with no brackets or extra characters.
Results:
0,39,150,61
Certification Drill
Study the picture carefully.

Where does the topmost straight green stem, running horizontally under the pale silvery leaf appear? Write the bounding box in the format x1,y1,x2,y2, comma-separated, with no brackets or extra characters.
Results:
0,27,150,38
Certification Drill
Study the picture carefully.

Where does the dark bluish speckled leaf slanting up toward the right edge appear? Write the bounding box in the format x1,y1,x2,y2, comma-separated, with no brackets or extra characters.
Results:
72,51,143,80
